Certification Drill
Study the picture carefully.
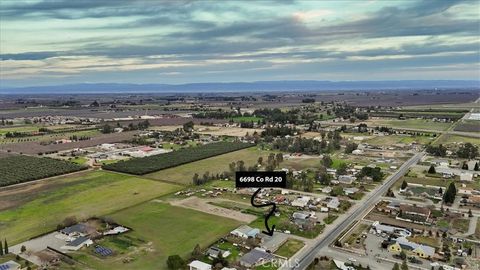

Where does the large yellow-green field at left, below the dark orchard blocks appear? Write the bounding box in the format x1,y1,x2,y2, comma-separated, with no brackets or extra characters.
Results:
0,171,179,244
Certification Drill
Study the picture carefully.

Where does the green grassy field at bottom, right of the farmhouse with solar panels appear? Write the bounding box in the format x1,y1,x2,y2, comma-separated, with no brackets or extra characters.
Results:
75,202,240,270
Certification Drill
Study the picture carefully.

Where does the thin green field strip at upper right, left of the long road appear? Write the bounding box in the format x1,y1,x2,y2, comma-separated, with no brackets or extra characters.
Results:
366,119,451,130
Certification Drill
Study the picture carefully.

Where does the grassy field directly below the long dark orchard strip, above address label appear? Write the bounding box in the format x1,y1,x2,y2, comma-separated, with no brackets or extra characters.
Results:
145,147,270,185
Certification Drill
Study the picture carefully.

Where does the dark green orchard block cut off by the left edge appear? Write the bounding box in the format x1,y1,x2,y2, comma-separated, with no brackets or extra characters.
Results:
0,155,86,186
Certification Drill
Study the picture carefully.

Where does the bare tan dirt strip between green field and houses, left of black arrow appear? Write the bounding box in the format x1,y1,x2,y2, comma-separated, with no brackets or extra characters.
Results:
170,196,257,223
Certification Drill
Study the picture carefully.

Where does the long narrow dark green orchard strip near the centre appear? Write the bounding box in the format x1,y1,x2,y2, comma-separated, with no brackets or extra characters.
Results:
104,142,252,175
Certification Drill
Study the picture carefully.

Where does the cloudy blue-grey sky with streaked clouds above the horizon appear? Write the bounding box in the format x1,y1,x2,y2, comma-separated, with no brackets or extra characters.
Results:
0,0,480,87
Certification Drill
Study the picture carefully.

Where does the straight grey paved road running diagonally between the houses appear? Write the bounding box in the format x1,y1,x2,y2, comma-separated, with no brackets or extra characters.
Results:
281,152,425,270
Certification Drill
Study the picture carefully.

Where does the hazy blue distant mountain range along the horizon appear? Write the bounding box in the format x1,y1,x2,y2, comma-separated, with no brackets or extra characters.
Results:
0,80,480,95
